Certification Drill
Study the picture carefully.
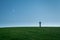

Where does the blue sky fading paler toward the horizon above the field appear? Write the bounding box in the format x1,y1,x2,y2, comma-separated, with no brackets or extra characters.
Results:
0,0,60,26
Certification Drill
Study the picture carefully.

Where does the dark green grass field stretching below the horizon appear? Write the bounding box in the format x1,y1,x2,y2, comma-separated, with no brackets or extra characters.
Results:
0,27,60,40
